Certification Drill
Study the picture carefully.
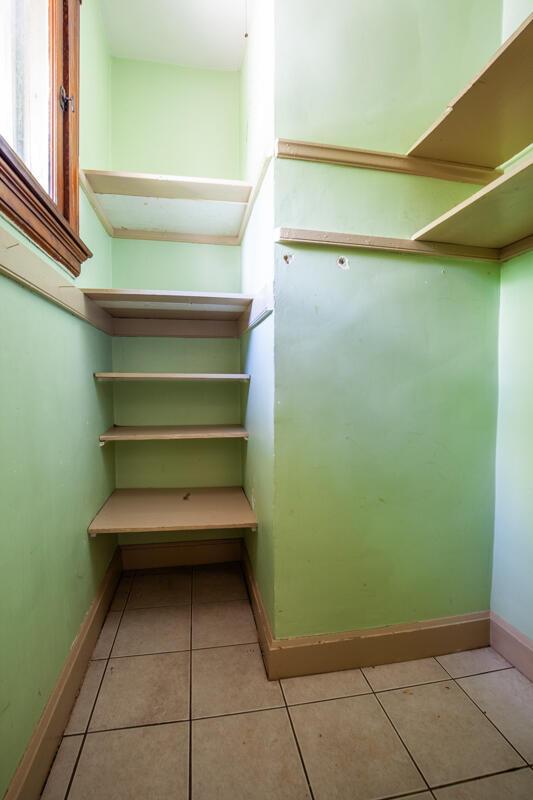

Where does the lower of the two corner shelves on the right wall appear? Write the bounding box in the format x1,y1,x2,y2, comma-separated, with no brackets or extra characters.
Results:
413,158,533,248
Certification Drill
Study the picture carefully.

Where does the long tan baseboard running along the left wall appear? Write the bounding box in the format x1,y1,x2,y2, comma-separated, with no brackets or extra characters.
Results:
4,549,122,800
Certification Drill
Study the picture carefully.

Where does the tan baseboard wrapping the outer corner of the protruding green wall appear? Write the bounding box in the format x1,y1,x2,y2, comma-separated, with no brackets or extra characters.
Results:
243,553,489,680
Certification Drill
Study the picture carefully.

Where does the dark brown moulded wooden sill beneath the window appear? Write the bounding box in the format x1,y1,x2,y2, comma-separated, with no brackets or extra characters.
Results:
0,136,92,275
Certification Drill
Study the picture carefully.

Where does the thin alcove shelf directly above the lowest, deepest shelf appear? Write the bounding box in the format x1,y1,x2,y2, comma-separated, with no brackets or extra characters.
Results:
100,425,248,442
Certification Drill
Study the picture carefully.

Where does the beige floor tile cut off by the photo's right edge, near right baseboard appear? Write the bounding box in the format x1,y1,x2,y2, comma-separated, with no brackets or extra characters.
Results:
458,669,533,764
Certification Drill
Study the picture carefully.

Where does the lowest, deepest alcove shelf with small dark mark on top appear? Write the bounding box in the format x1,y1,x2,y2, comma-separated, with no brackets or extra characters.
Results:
88,486,257,536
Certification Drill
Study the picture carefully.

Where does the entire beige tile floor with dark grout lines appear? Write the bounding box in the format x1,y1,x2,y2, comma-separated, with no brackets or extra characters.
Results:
42,564,533,800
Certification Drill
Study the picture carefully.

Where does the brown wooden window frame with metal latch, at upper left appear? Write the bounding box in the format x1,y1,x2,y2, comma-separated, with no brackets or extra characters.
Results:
0,0,92,275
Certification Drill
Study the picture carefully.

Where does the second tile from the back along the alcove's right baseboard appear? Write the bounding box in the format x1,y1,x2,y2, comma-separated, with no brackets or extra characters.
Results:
192,600,257,649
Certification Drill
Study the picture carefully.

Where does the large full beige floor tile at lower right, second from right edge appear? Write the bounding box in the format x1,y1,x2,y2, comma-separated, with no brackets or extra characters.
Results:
379,681,523,786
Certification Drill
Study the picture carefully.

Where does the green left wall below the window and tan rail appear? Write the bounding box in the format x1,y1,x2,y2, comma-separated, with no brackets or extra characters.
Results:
0,277,115,796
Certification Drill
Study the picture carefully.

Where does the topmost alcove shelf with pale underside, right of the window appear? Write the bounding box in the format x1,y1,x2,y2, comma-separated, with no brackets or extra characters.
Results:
80,170,252,245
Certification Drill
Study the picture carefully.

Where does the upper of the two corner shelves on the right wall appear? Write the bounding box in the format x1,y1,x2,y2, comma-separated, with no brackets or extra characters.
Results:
408,14,533,168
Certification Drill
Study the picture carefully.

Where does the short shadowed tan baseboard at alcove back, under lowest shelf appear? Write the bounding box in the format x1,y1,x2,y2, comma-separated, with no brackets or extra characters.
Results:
120,538,242,570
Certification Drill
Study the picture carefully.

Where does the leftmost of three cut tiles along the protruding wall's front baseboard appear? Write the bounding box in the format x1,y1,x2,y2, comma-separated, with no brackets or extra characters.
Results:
281,669,371,705
